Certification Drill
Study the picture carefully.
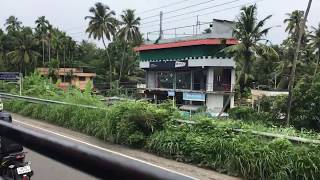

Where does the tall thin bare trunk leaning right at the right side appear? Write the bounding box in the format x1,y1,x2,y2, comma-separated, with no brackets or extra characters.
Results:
287,0,312,126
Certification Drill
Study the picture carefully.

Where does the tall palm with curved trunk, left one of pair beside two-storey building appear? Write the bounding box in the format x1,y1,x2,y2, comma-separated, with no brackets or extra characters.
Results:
85,2,117,88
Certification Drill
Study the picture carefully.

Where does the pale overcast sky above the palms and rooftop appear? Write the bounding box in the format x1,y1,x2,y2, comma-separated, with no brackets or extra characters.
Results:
0,0,320,44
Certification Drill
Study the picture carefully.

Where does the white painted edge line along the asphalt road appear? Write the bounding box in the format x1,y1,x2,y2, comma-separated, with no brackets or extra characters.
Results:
13,119,197,180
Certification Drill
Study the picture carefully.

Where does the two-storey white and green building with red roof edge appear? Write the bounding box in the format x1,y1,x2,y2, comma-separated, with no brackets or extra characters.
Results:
135,19,238,113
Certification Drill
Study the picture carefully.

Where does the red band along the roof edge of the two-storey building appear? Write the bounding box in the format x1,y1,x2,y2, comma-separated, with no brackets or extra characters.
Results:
134,39,238,51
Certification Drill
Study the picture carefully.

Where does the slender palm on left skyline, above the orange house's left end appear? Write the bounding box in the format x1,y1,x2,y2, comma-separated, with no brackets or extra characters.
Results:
35,16,51,65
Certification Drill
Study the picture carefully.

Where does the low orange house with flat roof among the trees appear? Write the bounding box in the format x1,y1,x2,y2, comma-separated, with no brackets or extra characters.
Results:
37,68,97,90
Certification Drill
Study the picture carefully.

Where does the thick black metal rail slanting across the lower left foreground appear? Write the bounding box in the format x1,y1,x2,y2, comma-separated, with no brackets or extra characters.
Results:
0,121,193,180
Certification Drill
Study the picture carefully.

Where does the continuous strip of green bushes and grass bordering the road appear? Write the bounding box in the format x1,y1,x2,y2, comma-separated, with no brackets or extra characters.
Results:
4,73,320,180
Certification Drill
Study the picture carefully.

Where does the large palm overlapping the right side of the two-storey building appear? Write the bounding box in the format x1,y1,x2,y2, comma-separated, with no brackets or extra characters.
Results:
219,5,277,116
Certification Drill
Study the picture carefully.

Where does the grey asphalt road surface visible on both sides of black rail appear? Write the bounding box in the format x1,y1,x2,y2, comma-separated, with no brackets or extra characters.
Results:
9,114,238,180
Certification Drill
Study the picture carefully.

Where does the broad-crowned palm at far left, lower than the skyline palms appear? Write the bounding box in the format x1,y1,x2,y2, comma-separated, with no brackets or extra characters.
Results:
7,28,40,74
